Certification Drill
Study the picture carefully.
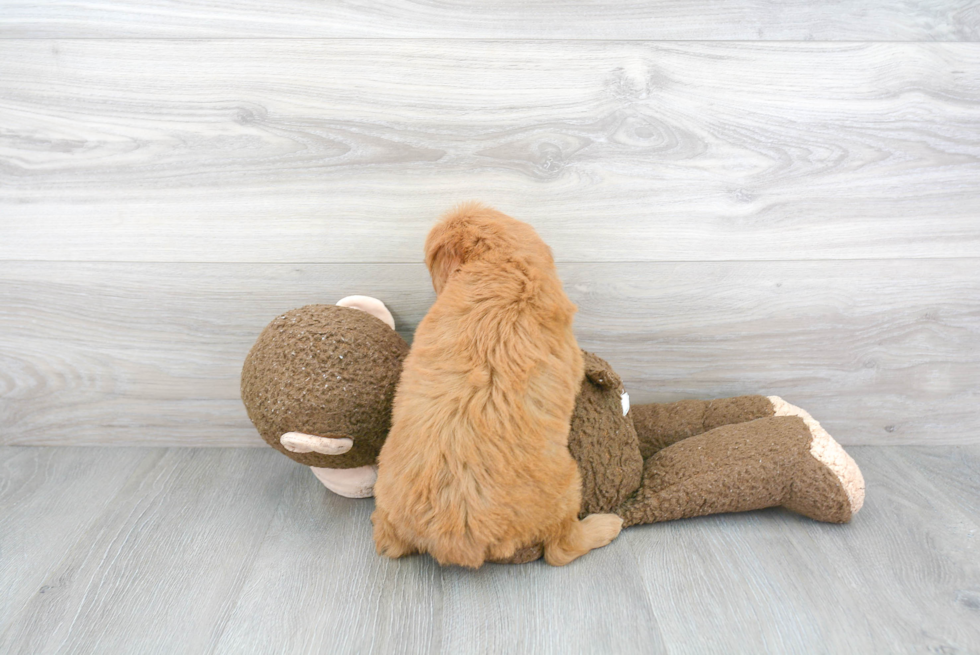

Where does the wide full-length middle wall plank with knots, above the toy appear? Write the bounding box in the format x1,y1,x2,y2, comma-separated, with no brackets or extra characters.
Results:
0,40,980,263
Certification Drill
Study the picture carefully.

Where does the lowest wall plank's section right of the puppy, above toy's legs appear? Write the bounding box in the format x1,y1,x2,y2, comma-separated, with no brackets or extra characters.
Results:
561,260,980,444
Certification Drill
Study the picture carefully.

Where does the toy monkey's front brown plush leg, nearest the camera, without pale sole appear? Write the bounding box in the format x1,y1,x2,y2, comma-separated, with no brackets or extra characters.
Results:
617,416,851,527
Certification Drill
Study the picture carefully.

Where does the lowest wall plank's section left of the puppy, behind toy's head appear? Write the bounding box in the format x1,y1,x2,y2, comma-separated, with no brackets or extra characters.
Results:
0,263,432,445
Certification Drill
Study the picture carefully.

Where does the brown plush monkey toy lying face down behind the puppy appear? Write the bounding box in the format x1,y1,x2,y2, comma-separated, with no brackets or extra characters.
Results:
242,296,864,562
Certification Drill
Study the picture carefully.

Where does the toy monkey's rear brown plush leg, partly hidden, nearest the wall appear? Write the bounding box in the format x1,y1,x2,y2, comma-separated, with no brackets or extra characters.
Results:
630,396,773,459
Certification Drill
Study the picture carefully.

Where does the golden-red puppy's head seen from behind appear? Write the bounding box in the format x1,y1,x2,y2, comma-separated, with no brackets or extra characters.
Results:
425,202,554,294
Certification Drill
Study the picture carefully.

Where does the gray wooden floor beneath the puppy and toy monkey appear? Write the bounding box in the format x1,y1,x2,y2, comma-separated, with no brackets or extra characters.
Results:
0,446,980,654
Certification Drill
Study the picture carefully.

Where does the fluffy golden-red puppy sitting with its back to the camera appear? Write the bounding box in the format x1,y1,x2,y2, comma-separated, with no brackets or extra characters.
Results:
371,204,622,568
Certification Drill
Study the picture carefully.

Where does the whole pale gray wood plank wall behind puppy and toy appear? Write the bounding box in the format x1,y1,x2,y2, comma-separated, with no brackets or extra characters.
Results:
0,0,980,446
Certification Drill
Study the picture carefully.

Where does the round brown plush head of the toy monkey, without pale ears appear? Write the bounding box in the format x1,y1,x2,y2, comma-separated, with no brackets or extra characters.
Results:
242,305,408,468
